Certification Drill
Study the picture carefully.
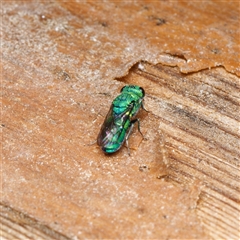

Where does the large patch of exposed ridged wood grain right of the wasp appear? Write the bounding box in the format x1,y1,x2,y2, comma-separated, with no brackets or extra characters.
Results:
119,63,240,239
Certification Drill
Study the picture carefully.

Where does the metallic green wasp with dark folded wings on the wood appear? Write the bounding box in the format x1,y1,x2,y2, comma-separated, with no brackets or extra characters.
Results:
97,85,145,153
